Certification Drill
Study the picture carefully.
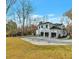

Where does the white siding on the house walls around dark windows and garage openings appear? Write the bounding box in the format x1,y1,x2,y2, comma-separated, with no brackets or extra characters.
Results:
36,23,66,38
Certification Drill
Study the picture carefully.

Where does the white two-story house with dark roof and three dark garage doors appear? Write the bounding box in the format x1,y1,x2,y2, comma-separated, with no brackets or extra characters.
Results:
36,22,67,38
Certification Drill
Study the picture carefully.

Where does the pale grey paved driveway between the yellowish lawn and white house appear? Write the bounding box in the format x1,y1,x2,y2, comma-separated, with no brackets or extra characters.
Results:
21,36,72,45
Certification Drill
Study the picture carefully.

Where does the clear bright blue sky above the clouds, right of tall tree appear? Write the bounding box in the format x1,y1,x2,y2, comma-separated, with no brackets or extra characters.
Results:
31,0,72,16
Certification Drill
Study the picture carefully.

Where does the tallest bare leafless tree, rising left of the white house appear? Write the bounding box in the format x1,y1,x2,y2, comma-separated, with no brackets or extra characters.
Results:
17,0,32,34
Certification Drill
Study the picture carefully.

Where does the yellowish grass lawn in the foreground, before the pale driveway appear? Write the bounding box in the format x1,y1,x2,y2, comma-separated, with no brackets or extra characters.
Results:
6,37,72,59
